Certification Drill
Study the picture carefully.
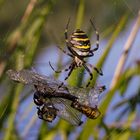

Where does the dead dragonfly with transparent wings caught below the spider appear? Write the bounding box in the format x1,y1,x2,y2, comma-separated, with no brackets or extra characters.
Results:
7,70,105,125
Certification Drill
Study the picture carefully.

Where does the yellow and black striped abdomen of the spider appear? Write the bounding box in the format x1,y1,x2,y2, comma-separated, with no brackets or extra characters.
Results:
70,29,90,52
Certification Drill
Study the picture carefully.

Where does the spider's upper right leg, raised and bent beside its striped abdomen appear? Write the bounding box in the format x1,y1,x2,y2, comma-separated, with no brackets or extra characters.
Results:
90,19,99,52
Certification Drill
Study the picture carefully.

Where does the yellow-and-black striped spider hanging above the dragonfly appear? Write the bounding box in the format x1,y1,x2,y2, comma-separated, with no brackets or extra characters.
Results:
49,18,103,87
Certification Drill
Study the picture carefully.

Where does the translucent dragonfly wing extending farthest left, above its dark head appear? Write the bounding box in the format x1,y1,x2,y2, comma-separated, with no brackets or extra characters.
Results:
7,69,66,91
